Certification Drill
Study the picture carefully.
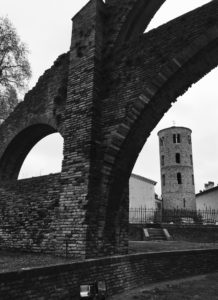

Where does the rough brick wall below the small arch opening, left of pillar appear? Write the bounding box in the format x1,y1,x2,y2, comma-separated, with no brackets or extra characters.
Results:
0,174,60,253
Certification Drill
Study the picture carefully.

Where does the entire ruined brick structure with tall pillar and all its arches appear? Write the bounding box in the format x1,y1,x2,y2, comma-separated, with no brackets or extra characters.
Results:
0,0,218,259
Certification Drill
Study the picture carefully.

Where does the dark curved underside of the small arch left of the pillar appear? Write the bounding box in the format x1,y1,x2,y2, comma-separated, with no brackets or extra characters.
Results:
0,123,57,181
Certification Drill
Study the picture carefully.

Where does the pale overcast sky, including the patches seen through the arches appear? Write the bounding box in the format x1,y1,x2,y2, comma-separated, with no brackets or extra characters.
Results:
0,0,218,194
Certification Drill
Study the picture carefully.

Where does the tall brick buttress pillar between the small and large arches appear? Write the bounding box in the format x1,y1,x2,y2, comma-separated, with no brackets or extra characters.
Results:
55,0,104,257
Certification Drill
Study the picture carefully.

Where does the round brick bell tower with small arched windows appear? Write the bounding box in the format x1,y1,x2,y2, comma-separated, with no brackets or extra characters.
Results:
158,126,196,210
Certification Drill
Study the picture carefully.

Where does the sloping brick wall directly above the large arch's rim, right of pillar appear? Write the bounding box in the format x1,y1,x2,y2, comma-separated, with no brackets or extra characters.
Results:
103,1,217,137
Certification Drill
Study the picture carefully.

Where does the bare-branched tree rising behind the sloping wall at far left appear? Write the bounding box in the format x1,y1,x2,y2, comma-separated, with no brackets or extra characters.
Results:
0,17,31,119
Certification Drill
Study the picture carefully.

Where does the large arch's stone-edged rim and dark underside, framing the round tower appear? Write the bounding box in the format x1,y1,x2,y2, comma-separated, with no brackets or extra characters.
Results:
103,26,218,216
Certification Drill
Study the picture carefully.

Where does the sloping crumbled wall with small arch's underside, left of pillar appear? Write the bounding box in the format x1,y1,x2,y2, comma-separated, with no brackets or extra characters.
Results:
0,54,69,181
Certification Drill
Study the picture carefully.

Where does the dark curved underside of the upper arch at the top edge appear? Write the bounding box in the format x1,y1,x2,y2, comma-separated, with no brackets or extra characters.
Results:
115,0,166,48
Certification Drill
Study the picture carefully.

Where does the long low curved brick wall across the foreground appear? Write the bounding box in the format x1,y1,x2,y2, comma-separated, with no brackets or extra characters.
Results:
0,249,218,300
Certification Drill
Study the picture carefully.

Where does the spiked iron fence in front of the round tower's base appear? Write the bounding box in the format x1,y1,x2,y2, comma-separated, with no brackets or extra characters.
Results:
129,207,218,225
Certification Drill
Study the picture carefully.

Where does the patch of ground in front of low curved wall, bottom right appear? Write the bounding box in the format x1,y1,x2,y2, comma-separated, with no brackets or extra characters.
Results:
108,273,218,300
